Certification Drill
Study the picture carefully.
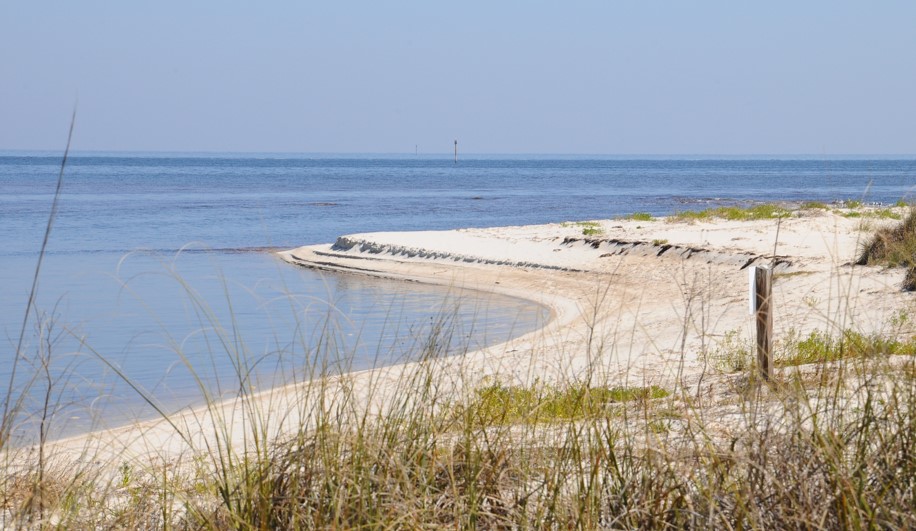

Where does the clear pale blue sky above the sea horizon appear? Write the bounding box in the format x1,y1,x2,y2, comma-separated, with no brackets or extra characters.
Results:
0,0,916,154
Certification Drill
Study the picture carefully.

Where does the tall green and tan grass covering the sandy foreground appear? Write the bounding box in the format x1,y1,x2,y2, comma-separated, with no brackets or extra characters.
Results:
0,328,916,529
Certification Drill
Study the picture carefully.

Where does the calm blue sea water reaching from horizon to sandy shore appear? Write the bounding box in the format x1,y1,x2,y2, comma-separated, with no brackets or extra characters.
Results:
0,153,916,440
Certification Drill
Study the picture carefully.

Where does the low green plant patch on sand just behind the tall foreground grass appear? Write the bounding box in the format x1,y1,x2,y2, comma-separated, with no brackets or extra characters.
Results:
461,383,669,426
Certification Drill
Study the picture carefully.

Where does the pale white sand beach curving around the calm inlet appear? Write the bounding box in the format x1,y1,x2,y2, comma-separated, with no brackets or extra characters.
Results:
12,210,916,474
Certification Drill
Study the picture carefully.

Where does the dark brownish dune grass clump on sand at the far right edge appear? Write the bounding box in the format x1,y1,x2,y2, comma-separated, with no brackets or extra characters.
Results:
856,208,916,291
